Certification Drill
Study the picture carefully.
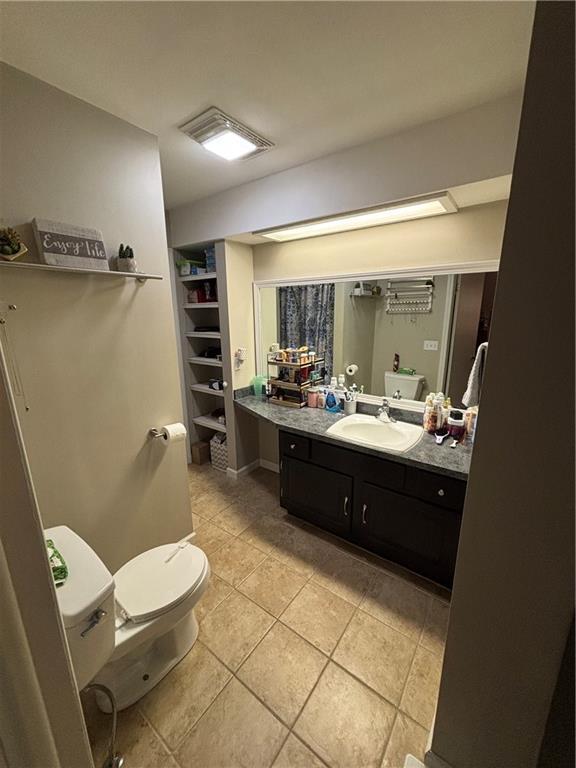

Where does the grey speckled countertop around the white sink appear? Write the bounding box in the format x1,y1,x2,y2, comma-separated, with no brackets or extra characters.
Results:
235,395,472,480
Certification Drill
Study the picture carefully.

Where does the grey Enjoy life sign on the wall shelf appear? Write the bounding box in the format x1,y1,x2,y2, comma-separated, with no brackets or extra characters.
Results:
32,219,109,271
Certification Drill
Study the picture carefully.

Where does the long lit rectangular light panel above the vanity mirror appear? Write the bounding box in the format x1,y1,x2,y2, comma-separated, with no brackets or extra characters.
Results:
252,192,458,243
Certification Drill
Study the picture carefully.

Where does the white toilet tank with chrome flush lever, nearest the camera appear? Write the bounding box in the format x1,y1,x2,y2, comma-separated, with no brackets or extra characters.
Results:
44,525,115,691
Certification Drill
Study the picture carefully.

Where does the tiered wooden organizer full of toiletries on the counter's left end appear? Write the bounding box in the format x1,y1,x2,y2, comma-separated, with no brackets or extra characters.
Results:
267,348,324,408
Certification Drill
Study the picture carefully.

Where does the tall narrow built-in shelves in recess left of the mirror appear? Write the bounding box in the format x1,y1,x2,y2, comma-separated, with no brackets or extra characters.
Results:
173,243,232,468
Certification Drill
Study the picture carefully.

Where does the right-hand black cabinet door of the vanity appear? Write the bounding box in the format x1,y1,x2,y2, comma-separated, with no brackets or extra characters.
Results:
354,482,460,587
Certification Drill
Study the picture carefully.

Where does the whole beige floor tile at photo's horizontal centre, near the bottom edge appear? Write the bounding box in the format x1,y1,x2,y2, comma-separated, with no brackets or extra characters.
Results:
236,623,327,726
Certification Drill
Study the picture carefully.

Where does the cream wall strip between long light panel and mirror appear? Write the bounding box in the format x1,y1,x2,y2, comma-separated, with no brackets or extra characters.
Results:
253,201,507,281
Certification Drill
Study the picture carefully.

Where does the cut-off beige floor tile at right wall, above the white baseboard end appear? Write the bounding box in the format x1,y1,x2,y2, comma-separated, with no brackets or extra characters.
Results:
400,646,442,730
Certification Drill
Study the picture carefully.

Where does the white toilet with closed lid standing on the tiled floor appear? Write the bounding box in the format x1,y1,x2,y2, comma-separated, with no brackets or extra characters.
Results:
45,525,210,711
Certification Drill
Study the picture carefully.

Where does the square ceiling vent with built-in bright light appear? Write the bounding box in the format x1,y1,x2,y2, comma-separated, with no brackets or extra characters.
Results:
180,107,274,160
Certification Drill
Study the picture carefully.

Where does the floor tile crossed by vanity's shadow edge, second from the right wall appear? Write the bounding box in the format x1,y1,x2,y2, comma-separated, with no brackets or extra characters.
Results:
360,573,430,640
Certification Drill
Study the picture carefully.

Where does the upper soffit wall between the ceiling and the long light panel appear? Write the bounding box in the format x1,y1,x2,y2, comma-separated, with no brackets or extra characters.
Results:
169,93,521,247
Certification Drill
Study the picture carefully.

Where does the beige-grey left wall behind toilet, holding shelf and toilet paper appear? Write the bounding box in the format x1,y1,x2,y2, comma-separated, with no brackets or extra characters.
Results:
0,65,191,570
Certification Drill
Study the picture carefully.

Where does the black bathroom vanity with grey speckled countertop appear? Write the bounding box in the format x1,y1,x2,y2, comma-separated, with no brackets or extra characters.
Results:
236,396,472,588
